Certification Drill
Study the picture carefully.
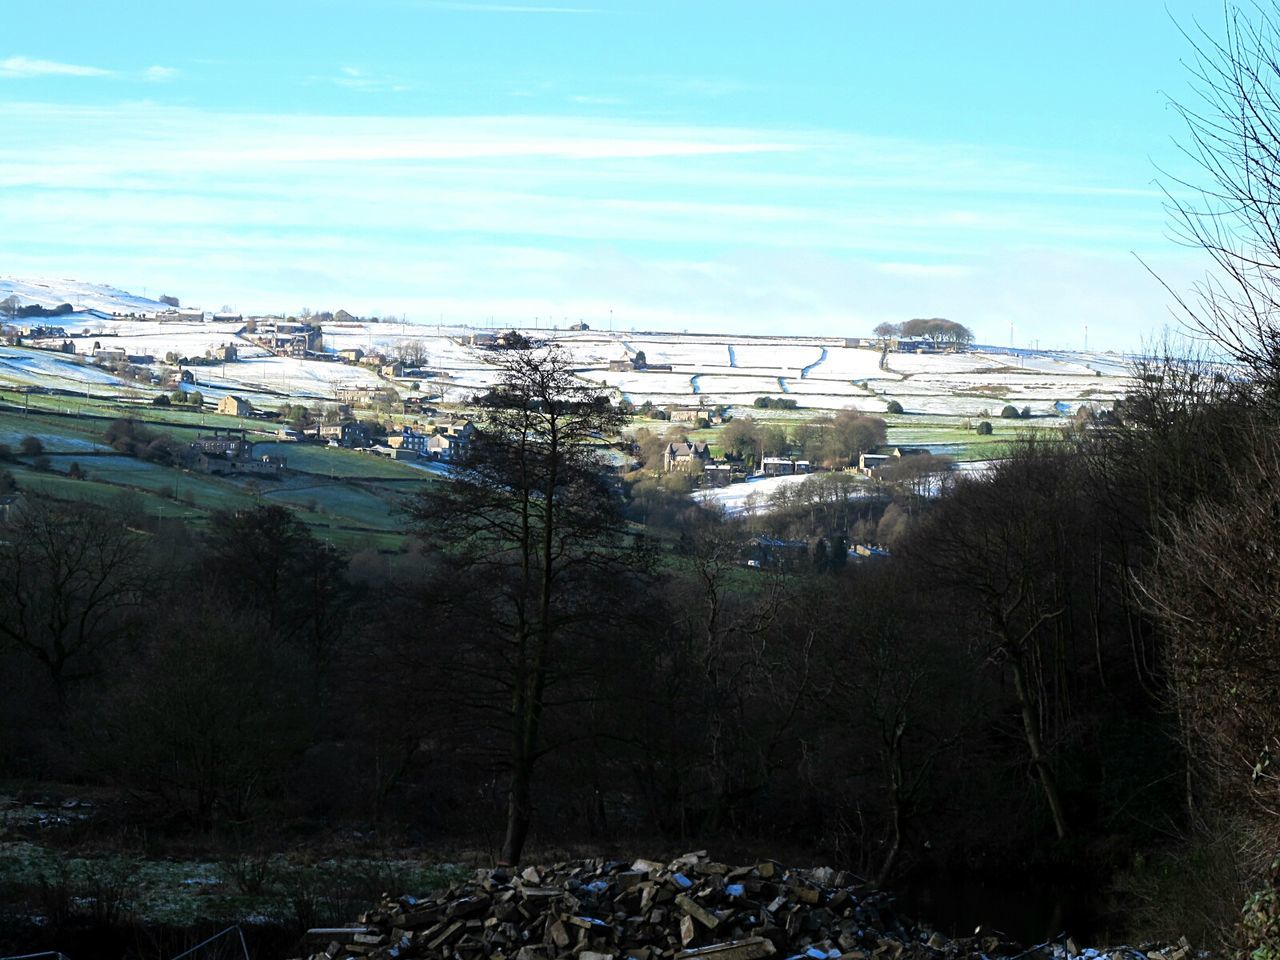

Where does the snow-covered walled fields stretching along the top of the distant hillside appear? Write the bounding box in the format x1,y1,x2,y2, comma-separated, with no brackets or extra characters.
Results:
0,278,1130,417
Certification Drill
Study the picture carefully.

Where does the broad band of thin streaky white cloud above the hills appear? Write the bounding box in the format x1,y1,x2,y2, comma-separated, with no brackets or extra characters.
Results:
0,101,1167,348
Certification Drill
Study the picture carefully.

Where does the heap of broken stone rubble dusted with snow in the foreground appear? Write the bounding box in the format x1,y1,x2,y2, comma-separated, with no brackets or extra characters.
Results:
294,854,1190,960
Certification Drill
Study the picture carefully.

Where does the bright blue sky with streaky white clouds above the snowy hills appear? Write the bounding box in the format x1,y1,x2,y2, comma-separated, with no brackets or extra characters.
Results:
0,0,1239,351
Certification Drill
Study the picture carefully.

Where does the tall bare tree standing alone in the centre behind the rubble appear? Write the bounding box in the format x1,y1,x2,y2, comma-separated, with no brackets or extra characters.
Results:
412,349,643,863
